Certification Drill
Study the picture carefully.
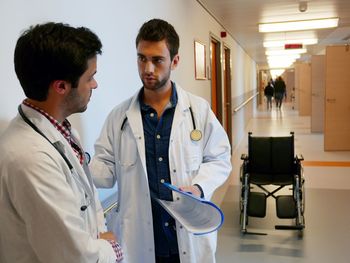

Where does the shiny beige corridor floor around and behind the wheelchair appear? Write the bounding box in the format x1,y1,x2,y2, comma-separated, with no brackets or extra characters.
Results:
217,104,350,263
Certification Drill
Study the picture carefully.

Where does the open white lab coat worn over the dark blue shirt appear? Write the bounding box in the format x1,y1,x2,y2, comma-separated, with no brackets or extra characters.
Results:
90,85,231,263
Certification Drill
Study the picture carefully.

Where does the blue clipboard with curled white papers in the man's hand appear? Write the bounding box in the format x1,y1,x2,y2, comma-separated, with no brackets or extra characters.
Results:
157,183,224,235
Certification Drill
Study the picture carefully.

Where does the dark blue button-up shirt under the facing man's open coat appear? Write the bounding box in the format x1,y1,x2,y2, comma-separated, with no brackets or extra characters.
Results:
139,83,179,257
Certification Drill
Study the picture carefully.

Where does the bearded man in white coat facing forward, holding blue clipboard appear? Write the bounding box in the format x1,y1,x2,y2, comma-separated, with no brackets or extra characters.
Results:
90,19,231,263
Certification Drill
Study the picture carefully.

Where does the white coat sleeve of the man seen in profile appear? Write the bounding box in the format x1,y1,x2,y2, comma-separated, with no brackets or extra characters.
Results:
9,152,116,263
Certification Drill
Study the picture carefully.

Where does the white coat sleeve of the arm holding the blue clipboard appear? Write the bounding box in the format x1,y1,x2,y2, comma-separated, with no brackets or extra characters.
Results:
192,102,232,199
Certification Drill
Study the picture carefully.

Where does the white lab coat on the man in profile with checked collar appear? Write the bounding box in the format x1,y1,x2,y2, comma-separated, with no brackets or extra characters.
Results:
0,105,116,263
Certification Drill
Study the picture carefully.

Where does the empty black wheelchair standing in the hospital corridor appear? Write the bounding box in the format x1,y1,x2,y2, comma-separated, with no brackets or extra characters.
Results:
240,132,305,235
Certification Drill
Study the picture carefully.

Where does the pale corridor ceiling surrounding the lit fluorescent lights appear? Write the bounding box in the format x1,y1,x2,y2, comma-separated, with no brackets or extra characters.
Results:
198,0,350,68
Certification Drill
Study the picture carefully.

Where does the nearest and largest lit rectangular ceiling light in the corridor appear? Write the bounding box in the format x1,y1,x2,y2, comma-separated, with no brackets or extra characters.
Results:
259,17,339,33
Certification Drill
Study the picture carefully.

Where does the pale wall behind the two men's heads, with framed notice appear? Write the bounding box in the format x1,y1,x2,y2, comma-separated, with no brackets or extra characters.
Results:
0,0,256,198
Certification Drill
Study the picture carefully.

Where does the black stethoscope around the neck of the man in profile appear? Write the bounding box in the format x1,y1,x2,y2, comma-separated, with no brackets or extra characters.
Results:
18,105,91,211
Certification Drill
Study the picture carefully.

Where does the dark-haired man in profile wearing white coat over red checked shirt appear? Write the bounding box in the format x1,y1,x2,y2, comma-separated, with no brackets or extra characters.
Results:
0,23,122,263
